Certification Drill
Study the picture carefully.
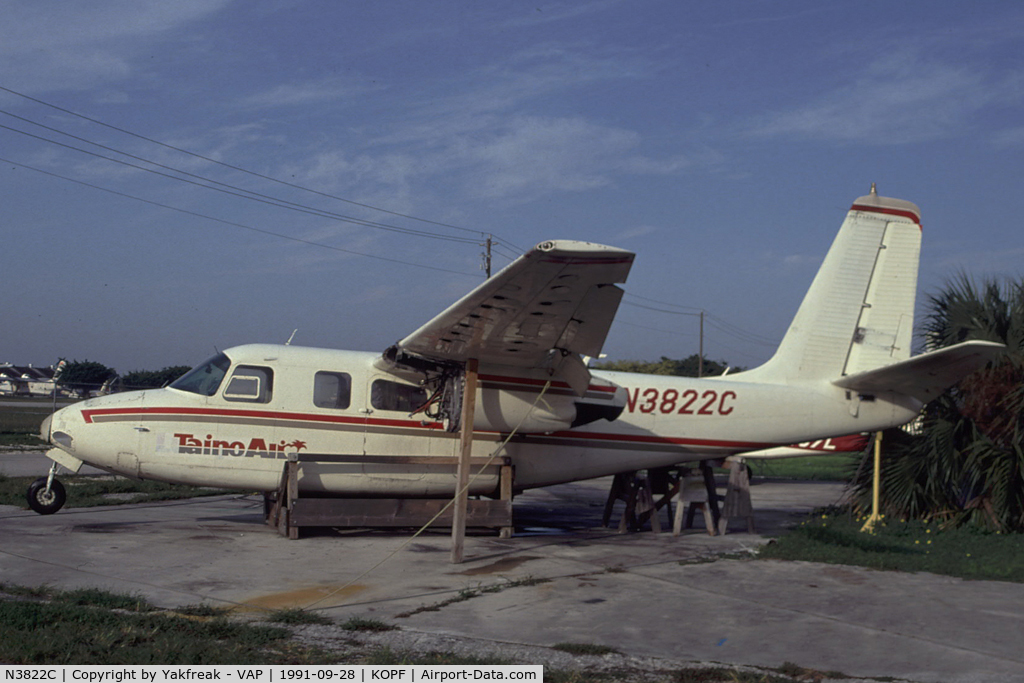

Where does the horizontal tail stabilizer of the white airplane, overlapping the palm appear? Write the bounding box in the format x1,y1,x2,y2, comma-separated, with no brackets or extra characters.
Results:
833,341,1007,402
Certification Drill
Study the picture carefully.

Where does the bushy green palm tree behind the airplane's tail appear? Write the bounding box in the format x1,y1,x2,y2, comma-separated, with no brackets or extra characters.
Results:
853,274,1024,531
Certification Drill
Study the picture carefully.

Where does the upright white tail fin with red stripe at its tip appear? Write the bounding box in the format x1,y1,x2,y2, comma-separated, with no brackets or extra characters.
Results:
744,184,921,382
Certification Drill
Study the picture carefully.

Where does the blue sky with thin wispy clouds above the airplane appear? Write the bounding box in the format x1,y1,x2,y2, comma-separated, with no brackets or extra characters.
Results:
0,0,1024,372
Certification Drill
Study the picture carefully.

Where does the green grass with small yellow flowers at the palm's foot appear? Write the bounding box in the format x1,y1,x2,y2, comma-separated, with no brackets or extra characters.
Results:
758,510,1024,583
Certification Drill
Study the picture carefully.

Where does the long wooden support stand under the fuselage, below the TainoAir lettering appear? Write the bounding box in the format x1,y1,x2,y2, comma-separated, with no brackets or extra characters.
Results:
264,456,513,539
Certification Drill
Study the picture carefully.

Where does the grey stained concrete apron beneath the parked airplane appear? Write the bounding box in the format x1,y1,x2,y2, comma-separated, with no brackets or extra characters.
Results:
0,458,1024,683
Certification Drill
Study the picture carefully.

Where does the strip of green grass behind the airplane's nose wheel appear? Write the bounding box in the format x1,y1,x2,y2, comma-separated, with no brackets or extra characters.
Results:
0,475,231,508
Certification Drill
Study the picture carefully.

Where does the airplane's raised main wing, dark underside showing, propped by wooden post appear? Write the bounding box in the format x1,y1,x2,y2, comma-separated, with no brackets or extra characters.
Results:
395,240,635,392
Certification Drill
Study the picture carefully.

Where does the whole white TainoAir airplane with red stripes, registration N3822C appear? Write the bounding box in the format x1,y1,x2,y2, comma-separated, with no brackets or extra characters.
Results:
29,186,1002,514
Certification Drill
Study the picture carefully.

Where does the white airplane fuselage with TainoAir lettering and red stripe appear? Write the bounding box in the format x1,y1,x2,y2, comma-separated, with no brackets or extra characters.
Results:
46,344,921,497
